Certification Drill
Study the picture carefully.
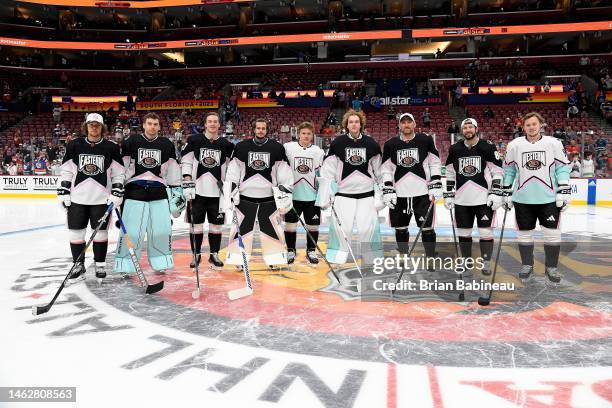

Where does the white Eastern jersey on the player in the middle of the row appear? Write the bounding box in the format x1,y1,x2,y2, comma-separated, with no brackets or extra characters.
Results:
284,142,325,201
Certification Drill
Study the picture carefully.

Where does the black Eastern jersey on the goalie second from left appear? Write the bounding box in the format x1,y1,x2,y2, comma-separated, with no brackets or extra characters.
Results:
121,134,181,199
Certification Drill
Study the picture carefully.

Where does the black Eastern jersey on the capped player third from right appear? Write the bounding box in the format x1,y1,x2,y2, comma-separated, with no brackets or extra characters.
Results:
382,133,441,197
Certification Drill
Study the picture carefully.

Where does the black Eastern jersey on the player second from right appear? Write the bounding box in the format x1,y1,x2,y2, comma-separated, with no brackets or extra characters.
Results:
446,139,504,205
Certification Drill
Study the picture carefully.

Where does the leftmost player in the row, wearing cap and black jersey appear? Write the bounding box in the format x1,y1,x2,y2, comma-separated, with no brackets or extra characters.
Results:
57,113,125,282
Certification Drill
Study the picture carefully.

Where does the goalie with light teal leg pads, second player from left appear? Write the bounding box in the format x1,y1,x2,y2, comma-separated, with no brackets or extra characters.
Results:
115,112,185,275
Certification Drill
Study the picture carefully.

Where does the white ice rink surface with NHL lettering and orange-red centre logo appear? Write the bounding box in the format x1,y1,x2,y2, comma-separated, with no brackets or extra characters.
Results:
0,199,612,408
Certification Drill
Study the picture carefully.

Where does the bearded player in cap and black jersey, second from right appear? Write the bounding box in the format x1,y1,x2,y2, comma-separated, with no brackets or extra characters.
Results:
444,118,504,275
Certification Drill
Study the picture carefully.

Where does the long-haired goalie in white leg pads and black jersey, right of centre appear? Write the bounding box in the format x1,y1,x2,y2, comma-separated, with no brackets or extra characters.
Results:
318,109,384,264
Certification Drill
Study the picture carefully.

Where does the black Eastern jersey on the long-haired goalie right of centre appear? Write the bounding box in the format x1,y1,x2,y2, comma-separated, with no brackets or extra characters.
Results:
321,135,382,194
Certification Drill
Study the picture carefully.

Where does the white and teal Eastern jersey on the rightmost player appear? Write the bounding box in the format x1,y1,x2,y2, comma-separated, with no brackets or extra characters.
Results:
504,136,570,204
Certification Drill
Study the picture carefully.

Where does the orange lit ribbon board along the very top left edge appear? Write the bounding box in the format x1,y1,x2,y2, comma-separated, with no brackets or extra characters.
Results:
14,0,255,9
